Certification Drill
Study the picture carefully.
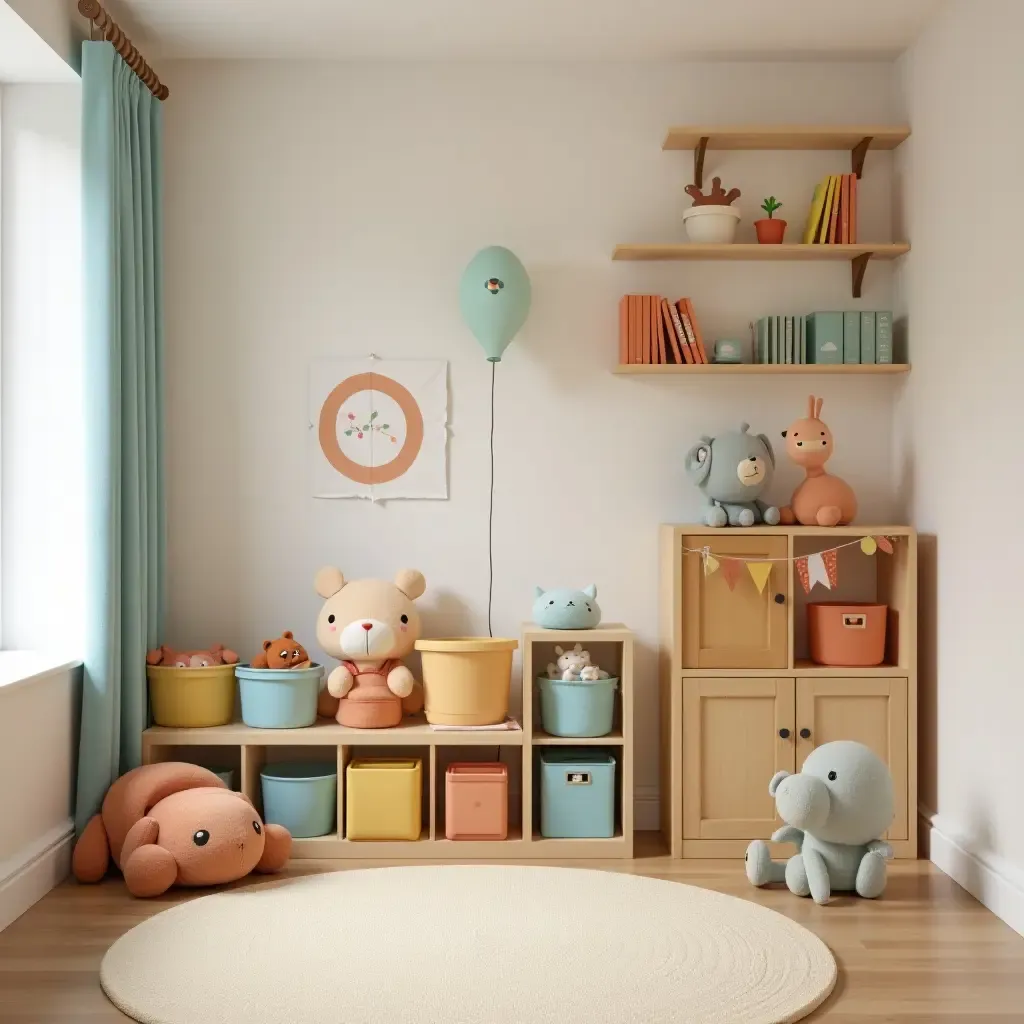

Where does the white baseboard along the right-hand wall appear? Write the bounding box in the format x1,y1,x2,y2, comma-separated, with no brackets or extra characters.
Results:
919,807,1024,935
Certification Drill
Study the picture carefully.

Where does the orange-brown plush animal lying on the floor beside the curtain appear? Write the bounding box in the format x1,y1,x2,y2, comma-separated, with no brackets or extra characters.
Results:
72,762,292,896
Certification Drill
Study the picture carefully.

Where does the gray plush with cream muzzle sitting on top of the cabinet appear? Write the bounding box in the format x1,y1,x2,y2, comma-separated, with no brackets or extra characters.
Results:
686,423,779,526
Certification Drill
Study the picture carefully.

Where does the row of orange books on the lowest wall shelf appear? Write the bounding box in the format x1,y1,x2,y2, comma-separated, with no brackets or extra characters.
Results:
618,295,709,364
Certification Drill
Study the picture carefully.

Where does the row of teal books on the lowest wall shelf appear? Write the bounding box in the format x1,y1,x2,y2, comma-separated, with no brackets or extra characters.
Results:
751,309,893,365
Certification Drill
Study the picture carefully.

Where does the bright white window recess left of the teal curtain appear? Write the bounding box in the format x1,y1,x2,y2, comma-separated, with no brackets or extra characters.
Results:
0,85,85,656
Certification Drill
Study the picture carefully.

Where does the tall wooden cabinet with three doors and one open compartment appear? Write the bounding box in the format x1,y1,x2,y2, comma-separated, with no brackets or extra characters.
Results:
659,525,918,858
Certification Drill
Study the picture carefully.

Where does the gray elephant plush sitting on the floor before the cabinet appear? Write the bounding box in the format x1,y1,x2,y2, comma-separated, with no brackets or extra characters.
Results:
743,739,894,905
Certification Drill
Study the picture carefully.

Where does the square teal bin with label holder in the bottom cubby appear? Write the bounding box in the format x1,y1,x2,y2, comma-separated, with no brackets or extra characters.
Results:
540,748,615,839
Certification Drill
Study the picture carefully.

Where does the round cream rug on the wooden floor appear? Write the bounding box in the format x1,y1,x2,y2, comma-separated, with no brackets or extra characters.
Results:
100,865,836,1024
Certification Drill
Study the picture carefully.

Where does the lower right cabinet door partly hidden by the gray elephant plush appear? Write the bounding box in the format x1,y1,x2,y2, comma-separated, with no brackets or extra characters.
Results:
797,678,909,839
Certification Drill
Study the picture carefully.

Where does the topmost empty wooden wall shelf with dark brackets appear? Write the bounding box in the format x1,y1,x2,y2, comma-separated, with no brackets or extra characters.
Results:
662,125,910,188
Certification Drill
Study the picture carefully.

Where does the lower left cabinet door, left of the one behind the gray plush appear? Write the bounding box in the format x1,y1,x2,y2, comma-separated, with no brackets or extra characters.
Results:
683,678,796,839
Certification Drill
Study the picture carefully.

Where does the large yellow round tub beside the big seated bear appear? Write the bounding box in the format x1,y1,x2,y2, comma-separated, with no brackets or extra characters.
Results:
416,637,519,725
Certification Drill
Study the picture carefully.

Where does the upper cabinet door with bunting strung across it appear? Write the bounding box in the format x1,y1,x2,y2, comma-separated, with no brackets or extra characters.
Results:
680,528,790,669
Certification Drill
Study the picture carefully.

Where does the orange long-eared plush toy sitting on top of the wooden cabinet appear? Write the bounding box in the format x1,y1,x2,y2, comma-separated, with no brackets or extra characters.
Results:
780,394,857,526
